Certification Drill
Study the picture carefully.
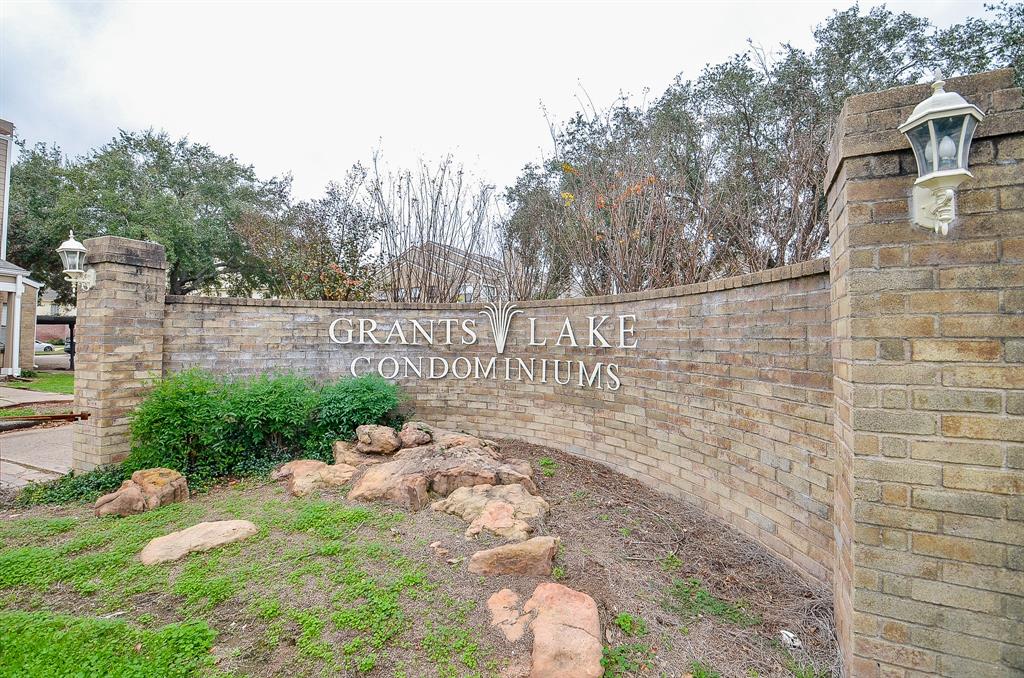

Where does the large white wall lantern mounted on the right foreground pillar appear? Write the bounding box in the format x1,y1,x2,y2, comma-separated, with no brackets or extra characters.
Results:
899,72,985,236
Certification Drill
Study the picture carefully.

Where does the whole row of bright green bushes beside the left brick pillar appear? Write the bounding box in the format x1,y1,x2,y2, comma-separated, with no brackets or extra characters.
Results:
125,371,401,484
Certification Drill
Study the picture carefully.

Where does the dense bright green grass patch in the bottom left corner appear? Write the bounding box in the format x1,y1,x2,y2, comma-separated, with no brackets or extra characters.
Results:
0,610,215,678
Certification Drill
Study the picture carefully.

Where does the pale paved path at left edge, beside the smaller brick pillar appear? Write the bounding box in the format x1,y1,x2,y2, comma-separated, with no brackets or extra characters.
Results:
0,426,75,488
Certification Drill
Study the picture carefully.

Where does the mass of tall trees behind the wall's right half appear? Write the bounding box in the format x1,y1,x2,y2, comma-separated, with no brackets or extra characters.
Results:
502,2,1024,296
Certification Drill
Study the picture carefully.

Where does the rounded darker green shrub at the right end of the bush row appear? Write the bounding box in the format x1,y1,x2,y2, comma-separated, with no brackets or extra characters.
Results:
307,375,403,459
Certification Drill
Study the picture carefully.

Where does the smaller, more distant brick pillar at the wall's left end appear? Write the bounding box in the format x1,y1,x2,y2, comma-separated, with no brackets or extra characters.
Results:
73,236,167,471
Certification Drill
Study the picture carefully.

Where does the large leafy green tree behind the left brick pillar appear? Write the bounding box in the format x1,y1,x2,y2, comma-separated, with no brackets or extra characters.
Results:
10,130,289,301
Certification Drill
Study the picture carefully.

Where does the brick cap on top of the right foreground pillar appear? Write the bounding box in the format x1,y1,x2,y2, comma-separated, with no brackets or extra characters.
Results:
825,69,1024,189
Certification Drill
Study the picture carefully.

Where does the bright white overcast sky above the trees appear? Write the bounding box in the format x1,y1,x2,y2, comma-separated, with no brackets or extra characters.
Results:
0,0,983,198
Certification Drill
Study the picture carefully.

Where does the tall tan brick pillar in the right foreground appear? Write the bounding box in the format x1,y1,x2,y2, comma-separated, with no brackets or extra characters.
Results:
826,70,1024,678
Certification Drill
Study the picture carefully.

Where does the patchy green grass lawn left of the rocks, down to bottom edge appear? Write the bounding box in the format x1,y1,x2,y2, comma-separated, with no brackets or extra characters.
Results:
0,482,498,678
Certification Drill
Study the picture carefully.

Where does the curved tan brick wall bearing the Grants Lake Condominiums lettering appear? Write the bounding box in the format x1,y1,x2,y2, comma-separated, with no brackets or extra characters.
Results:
163,260,833,581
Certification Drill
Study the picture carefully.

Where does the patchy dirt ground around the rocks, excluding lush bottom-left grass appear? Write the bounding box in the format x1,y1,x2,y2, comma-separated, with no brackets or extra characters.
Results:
0,440,836,678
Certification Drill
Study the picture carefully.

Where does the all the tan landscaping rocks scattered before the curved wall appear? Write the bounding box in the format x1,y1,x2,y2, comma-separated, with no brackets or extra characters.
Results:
95,422,603,678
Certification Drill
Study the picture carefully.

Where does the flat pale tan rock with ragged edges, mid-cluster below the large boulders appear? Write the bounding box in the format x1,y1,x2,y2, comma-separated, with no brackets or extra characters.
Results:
431,483,550,541
